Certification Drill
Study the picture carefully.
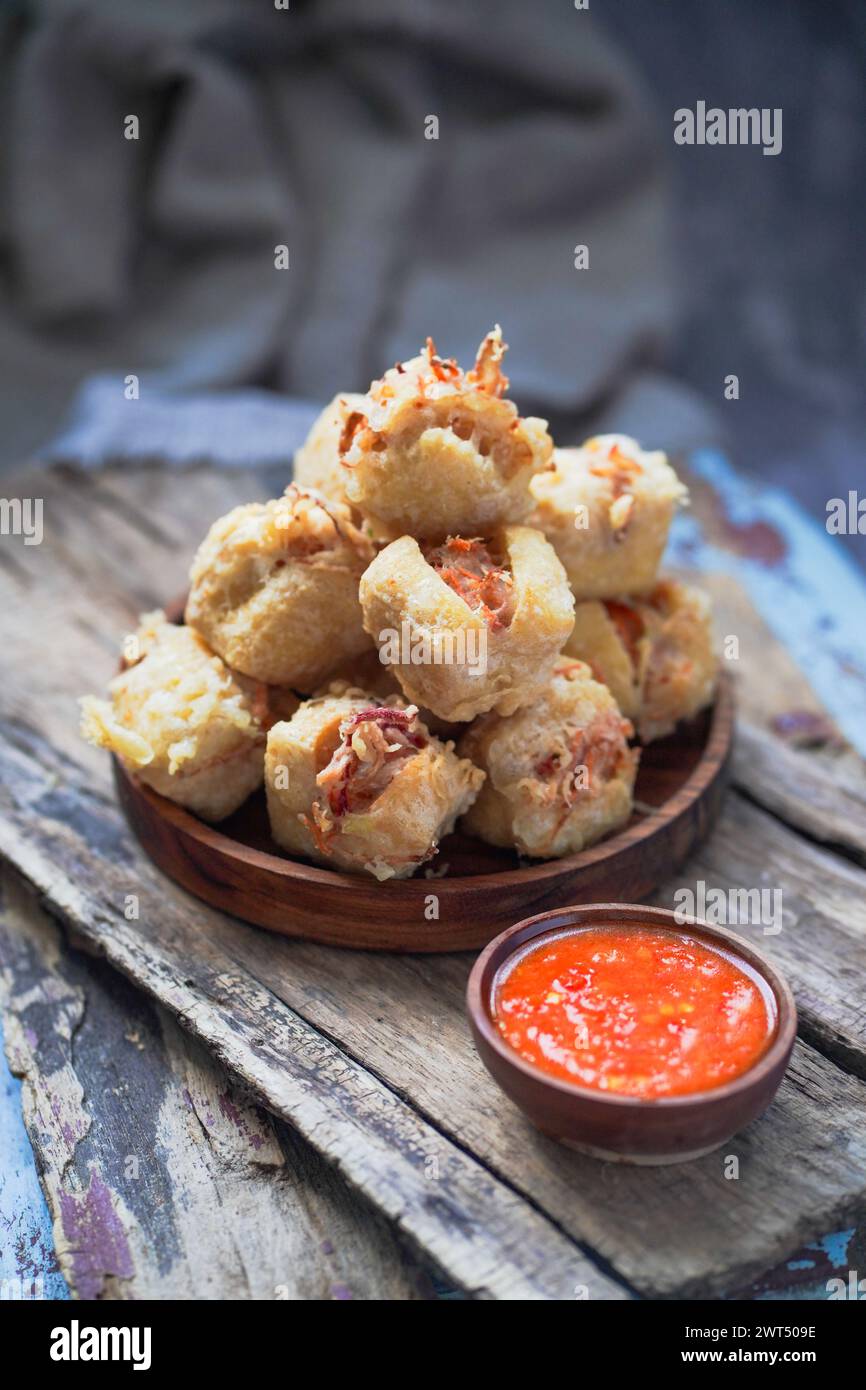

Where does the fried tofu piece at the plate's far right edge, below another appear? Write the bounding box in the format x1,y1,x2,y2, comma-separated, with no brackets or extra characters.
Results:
566,580,717,744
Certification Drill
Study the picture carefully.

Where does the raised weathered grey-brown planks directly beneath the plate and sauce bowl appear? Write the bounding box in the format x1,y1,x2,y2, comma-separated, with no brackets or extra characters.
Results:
0,470,866,1298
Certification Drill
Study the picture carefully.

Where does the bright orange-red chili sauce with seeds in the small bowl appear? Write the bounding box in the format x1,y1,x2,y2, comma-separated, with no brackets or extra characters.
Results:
493,926,777,1099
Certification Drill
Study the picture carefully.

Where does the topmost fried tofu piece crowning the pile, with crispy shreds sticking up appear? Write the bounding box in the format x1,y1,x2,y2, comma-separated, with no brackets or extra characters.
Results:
341,327,553,539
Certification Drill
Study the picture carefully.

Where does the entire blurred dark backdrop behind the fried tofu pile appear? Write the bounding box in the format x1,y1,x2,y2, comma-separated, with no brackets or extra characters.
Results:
0,0,866,557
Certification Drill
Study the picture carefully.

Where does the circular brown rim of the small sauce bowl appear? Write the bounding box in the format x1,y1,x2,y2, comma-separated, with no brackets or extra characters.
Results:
466,902,796,1112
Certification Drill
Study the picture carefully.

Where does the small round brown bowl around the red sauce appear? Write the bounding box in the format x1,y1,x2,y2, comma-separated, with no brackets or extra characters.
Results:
466,902,796,1165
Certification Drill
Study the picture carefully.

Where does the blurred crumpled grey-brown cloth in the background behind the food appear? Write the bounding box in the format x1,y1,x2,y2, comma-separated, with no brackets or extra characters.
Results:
0,0,712,464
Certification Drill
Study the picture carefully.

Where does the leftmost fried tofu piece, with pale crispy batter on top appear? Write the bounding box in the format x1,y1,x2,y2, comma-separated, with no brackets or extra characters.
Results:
81,613,268,820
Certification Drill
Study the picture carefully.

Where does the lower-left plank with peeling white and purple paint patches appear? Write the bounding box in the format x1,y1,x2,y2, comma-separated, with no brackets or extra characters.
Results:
0,872,432,1301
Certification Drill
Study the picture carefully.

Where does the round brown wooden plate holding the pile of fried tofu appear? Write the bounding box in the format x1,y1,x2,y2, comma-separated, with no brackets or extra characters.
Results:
115,674,734,951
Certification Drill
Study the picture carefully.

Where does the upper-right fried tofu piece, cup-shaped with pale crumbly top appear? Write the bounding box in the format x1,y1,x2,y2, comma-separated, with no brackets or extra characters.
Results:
530,435,688,599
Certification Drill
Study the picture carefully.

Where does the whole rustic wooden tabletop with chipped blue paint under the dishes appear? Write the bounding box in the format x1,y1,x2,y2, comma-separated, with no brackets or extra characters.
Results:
0,455,866,1300
